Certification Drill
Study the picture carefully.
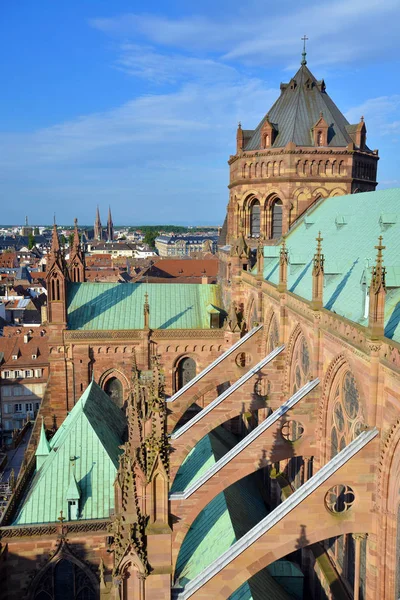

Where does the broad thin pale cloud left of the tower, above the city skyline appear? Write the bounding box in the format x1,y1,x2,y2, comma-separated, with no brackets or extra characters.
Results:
0,79,278,223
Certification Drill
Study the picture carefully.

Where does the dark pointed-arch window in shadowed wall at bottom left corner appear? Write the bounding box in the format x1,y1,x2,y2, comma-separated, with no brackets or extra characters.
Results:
34,559,99,600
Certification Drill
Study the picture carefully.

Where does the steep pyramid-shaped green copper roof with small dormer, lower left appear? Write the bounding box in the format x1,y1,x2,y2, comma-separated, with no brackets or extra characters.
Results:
13,381,126,525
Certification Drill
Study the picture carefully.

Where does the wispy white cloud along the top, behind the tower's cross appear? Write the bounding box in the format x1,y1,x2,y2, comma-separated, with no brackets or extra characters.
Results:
91,0,400,66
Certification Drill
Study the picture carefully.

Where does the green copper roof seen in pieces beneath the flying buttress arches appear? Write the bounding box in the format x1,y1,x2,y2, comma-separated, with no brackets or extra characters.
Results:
173,427,290,600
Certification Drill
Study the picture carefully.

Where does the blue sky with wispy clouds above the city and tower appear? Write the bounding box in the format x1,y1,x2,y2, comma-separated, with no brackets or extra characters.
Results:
0,0,400,224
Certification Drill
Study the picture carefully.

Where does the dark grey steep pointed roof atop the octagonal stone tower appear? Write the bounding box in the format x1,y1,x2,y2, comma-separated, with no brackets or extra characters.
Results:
244,65,360,150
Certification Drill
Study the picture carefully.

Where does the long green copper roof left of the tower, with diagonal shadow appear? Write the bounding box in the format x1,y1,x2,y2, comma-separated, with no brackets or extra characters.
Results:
67,283,222,331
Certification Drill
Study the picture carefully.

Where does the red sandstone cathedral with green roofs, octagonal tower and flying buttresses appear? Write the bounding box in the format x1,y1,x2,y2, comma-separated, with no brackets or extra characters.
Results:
0,52,400,600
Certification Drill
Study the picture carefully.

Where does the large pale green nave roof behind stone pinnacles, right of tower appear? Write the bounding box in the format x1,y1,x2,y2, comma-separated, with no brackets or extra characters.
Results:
264,188,400,341
